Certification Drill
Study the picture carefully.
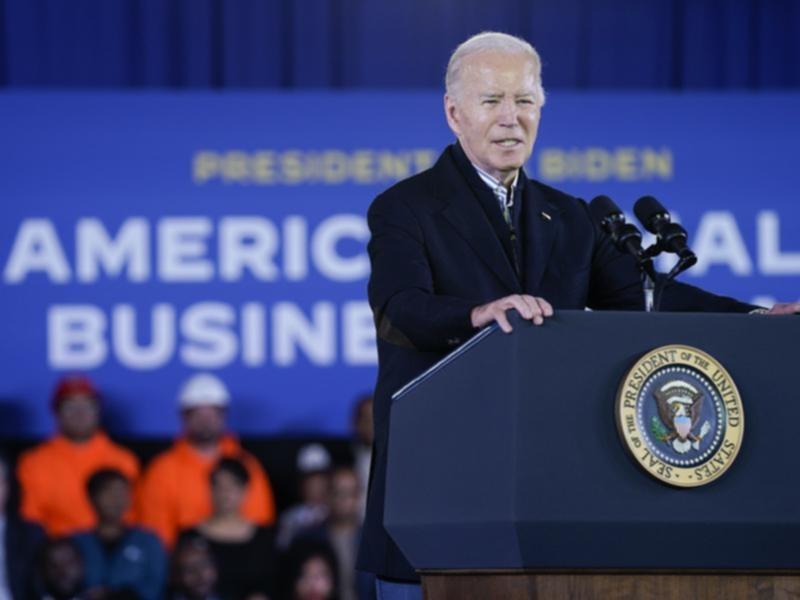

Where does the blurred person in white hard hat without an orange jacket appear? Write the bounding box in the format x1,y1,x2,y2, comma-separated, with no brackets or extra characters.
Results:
277,444,331,550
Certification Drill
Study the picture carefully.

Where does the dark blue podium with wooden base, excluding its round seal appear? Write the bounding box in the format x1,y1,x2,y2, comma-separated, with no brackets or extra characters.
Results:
385,311,800,600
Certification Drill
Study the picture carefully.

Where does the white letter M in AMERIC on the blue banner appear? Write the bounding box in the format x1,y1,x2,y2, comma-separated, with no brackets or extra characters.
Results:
75,218,150,283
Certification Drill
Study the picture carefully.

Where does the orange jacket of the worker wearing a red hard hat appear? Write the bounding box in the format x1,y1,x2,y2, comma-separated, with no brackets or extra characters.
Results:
17,432,139,536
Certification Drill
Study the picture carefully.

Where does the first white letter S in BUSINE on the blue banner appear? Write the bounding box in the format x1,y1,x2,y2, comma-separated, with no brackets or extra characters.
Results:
181,302,238,369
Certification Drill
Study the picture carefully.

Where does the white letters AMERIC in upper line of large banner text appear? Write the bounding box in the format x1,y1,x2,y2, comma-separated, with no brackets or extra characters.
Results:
3,214,369,284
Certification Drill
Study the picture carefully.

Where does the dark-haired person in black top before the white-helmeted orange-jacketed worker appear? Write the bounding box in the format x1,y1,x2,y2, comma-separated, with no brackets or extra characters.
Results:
181,458,275,600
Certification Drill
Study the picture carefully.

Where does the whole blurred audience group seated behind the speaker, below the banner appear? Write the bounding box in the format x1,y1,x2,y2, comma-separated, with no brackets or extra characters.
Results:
0,373,374,600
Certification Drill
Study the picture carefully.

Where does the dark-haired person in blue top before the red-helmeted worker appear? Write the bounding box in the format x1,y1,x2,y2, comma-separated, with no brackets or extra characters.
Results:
75,469,167,600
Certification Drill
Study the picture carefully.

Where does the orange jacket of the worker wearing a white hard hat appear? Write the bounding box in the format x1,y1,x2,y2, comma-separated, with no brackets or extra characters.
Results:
137,436,275,547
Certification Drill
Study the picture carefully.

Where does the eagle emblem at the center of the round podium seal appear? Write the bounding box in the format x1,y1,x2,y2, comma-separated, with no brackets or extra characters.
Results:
653,380,711,454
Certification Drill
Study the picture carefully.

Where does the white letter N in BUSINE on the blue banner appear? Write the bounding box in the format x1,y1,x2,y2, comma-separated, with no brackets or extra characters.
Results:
272,302,336,366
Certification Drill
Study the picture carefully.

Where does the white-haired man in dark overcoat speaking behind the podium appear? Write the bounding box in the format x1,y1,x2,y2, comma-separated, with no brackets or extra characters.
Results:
358,32,800,599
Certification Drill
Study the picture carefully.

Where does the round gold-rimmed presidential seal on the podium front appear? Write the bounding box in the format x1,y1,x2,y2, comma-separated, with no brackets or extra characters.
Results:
616,345,744,487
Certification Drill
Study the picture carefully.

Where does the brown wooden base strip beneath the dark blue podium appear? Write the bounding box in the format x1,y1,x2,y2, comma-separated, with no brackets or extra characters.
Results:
422,572,800,600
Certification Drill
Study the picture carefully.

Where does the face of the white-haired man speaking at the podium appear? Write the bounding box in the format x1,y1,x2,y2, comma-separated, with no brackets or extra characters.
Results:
445,51,542,183
